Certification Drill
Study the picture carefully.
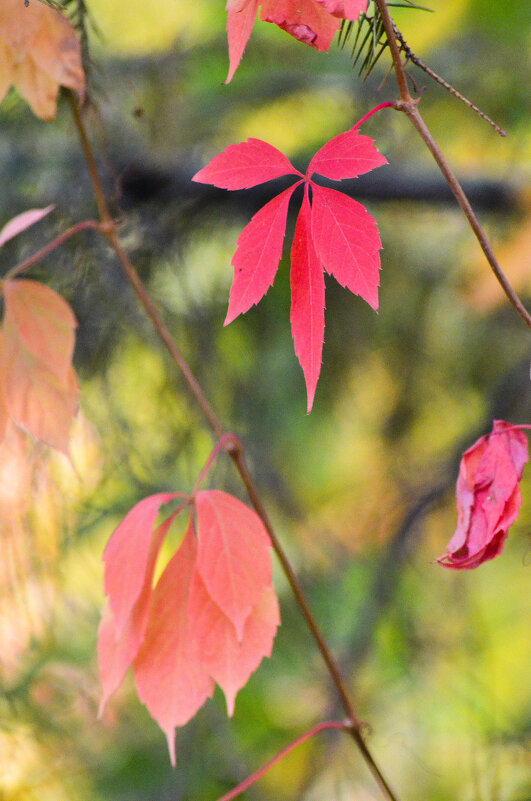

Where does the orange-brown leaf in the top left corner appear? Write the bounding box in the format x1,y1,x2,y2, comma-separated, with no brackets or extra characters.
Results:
0,0,85,120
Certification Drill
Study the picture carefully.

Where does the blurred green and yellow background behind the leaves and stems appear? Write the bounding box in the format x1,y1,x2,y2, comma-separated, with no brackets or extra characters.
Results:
0,0,531,801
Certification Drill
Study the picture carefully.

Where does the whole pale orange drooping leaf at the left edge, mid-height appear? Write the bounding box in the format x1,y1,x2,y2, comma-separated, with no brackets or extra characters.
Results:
0,276,79,454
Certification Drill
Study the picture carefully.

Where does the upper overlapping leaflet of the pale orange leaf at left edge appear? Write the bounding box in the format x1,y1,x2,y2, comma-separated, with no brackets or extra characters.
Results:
4,280,77,383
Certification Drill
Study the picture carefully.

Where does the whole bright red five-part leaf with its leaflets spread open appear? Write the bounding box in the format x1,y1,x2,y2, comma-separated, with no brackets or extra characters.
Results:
192,119,392,412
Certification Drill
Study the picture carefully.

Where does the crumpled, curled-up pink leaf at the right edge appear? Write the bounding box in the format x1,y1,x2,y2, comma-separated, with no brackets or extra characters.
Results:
437,420,529,569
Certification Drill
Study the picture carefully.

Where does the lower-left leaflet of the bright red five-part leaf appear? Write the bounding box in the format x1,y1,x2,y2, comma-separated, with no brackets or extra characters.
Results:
225,181,301,325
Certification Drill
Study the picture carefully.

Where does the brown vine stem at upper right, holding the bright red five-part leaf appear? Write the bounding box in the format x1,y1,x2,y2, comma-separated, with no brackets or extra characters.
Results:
375,0,531,329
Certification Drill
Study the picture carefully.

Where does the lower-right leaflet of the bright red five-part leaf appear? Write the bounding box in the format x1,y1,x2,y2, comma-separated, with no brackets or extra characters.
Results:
312,183,382,310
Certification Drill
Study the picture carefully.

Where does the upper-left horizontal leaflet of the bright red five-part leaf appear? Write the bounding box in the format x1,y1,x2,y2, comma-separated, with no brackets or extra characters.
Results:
192,139,301,189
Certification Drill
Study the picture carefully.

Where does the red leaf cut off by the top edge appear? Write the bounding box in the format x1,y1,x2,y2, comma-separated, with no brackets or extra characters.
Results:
225,0,367,83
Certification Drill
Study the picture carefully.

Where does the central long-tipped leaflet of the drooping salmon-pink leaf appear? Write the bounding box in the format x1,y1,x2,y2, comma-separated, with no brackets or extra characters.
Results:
134,523,214,765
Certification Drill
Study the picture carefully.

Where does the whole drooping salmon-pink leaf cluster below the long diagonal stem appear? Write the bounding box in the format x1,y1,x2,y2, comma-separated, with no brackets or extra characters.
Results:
98,490,280,764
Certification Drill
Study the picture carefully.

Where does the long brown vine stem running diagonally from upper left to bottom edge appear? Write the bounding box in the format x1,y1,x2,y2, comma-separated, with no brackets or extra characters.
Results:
67,90,399,801
